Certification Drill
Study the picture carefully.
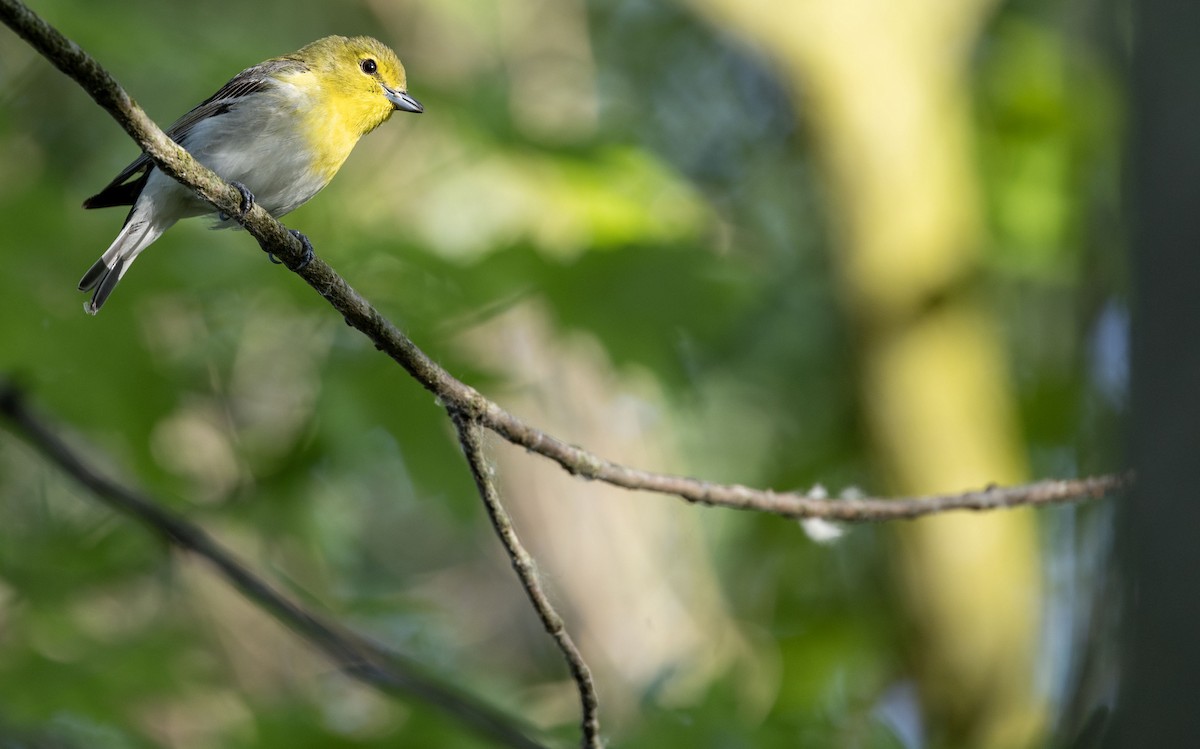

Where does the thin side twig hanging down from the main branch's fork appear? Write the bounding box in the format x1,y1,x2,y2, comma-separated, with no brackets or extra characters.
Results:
448,408,602,749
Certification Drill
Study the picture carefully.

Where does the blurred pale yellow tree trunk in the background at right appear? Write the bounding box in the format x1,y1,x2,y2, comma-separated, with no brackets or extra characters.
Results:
691,0,1045,749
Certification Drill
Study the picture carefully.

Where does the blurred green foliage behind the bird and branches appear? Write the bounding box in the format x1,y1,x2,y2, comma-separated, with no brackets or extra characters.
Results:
0,0,1123,748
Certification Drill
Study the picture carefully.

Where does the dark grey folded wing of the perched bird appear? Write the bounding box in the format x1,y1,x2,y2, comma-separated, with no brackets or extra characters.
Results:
83,58,308,208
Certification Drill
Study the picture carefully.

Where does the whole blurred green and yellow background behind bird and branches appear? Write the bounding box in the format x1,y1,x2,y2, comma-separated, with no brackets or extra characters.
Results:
0,0,1129,749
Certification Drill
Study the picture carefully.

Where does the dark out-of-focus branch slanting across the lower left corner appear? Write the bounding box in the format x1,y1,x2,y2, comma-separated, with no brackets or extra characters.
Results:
0,381,542,749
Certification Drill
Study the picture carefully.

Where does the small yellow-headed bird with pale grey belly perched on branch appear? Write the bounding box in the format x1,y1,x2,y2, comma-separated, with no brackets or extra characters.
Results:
79,36,425,314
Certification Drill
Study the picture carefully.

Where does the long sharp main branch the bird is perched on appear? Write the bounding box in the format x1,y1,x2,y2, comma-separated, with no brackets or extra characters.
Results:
0,0,1133,522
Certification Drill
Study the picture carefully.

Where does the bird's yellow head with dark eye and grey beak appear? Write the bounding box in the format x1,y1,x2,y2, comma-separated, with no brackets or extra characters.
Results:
286,36,424,140
